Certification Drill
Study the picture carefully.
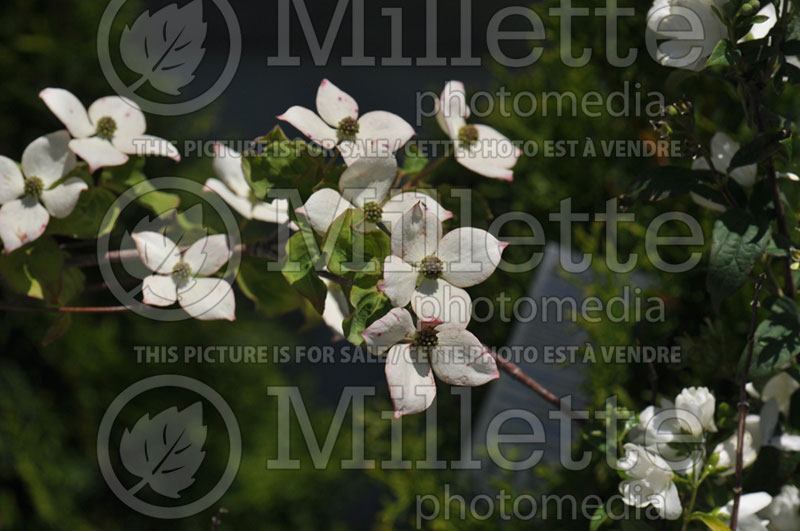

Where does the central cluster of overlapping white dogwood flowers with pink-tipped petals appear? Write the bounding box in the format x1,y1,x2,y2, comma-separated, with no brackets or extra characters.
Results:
256,80,520,416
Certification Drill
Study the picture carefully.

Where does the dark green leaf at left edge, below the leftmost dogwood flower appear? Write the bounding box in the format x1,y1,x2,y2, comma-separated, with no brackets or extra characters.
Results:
0,237,64,304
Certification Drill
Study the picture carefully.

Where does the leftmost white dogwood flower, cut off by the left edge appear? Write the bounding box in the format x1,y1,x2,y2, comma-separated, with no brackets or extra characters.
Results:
0,131,88,253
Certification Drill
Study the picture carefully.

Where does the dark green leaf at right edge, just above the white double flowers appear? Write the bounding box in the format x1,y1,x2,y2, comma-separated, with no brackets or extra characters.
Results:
740,297,800,379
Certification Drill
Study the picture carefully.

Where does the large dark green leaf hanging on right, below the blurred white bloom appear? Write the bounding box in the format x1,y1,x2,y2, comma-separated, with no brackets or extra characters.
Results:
706,209,770,308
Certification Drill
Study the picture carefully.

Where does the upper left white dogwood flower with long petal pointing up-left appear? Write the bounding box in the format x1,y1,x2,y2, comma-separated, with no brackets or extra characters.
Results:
39,88,181,172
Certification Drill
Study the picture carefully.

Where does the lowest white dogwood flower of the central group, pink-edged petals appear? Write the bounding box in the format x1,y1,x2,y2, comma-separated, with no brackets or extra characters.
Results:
361,308,500,418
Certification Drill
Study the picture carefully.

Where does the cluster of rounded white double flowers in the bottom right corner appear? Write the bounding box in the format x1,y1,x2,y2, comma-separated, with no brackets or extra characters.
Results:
618,373,800,530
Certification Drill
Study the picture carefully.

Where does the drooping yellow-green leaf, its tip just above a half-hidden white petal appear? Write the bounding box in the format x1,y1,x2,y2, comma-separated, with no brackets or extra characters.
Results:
281,227,328,315
